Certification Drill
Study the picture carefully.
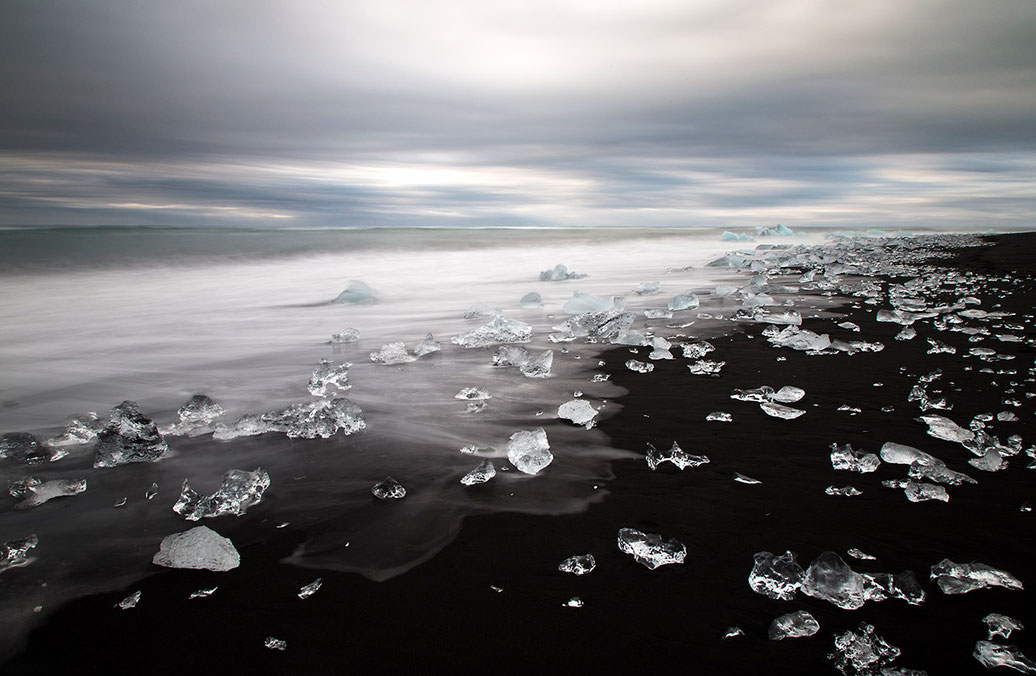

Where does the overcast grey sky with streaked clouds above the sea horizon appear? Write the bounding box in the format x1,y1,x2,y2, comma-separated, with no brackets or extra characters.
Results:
0,0,1036,230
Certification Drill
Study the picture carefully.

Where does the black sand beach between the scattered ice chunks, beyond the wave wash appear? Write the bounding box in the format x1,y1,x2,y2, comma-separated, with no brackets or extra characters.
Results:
2,234,1036,674
